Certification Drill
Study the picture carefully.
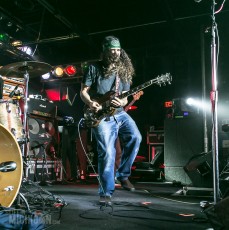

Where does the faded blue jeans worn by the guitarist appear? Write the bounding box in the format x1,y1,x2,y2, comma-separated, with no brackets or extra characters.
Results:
92,111,142,196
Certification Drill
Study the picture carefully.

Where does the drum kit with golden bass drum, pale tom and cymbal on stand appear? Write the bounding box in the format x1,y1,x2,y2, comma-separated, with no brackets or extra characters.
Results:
0,61,52,207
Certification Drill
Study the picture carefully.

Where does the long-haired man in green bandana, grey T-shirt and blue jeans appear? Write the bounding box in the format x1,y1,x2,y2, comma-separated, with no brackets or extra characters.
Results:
80,36,142,205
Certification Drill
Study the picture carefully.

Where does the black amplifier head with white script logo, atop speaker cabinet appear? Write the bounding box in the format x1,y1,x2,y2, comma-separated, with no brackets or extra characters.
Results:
28,98,57,118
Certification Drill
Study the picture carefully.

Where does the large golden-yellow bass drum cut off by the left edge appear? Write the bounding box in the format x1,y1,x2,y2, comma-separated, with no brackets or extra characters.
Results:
0,124,23,207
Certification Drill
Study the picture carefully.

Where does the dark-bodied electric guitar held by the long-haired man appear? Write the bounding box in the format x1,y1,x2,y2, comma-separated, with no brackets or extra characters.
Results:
84,73,172,127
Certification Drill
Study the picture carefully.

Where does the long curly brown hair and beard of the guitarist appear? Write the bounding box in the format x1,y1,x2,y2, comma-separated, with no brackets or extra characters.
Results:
102,49,135,82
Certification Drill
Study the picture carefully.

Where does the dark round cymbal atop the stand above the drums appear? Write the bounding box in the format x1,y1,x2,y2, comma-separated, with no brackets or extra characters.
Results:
0,61,52,78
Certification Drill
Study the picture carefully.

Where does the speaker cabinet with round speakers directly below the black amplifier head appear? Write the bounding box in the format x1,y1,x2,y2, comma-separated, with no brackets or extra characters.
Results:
28,115,58,158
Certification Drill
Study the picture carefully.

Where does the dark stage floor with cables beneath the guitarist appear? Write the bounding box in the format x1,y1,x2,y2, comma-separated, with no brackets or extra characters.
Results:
18,178,216,230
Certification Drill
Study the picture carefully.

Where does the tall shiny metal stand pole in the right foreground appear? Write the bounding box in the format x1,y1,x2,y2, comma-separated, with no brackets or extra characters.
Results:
210,0,220,203
